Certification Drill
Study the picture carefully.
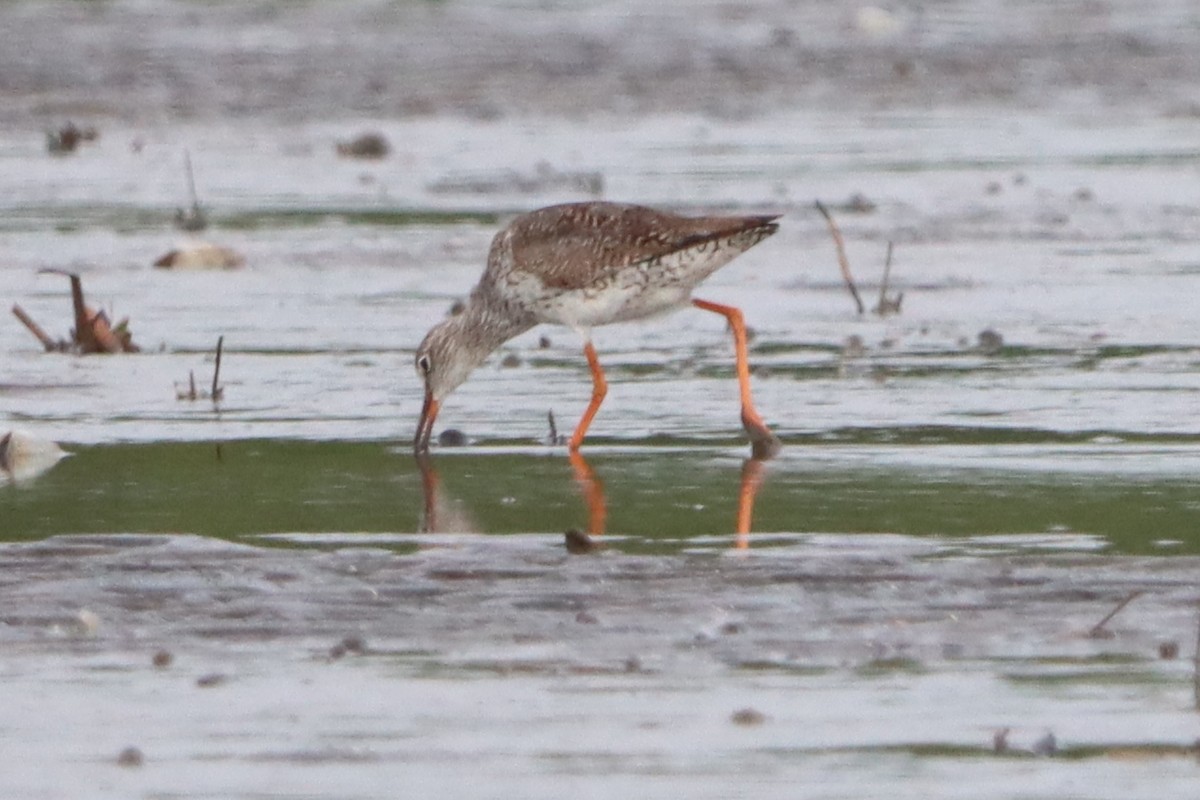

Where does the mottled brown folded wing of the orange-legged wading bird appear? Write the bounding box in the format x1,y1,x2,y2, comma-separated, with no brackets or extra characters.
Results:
496,203,778,291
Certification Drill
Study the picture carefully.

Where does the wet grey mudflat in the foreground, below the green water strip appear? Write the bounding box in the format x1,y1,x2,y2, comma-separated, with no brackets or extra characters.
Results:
0,535,1200,798
